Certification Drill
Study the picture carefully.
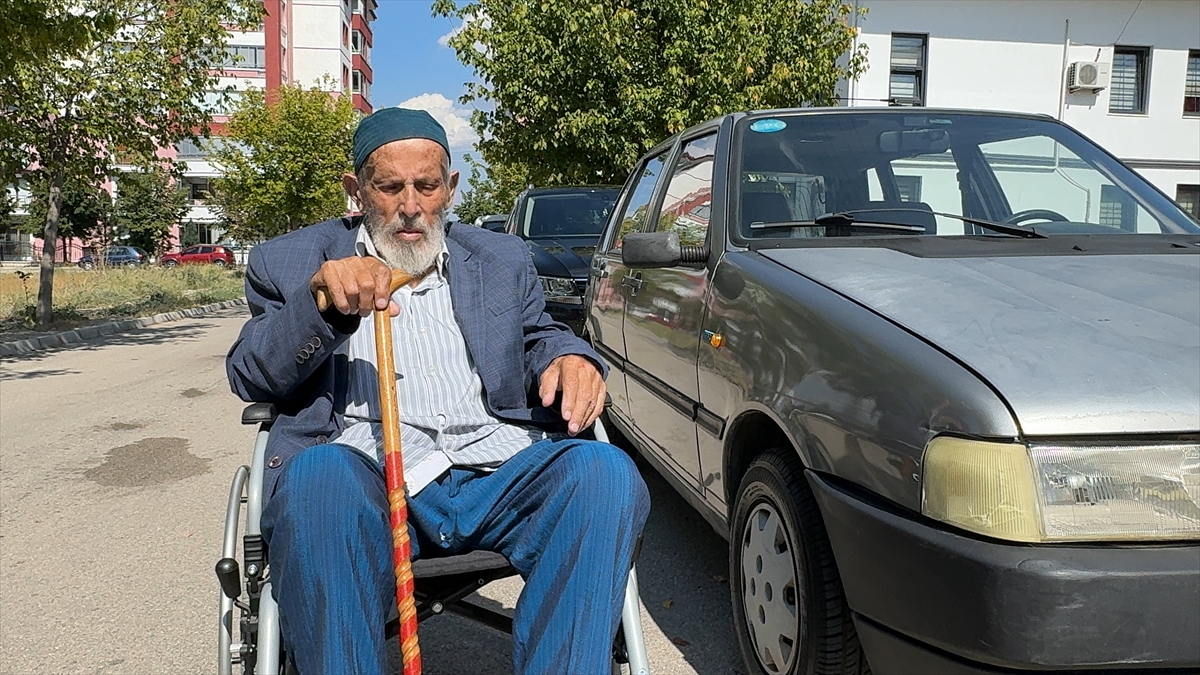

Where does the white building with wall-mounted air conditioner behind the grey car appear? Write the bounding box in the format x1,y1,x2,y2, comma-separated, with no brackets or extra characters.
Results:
841,0,1200,220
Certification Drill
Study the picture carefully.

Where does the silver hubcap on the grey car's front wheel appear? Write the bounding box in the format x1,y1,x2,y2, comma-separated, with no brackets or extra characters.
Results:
742,502,800,673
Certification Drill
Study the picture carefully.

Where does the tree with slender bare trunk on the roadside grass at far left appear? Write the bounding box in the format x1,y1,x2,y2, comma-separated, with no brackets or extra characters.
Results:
0,0,262,327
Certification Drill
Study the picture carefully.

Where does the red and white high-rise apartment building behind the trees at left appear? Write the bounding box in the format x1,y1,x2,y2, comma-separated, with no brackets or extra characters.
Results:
0,0,378,262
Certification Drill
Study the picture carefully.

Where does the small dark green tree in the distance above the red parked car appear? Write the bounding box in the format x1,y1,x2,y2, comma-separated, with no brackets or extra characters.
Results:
113,162,187,252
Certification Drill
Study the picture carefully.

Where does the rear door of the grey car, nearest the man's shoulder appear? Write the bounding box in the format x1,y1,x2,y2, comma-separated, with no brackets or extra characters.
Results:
587,150,667,422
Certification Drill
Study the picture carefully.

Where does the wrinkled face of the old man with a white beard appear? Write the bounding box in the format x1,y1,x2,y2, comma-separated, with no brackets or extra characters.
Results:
344,138,458,274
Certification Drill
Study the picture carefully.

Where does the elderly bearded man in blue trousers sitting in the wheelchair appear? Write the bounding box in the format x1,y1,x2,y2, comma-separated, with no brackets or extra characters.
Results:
227,108,649,675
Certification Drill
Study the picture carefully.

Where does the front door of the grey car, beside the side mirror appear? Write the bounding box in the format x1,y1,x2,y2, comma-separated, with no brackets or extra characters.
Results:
624,131,716,489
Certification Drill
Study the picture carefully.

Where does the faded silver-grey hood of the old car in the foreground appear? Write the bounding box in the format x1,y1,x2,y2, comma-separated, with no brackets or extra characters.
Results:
762,247,1200,436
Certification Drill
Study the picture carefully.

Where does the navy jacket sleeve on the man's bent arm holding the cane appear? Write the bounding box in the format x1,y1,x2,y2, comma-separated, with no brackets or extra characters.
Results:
226,245,360,404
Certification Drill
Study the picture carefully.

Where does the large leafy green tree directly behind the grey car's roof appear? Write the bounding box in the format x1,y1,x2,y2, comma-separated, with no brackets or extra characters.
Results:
433,0,865,185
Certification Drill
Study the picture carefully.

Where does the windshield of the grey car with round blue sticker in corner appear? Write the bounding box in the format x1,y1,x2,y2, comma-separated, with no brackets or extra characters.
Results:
734,110,1200,239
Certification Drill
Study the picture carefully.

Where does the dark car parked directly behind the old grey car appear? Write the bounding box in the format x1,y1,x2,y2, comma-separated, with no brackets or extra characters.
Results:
506,187,620,334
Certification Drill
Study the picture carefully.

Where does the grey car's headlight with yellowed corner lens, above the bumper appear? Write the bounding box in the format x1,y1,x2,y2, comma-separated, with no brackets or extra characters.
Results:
922,437,1200,542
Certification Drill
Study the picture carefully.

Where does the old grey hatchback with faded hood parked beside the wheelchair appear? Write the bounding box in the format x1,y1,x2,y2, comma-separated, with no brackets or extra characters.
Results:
587,108,1200,675
